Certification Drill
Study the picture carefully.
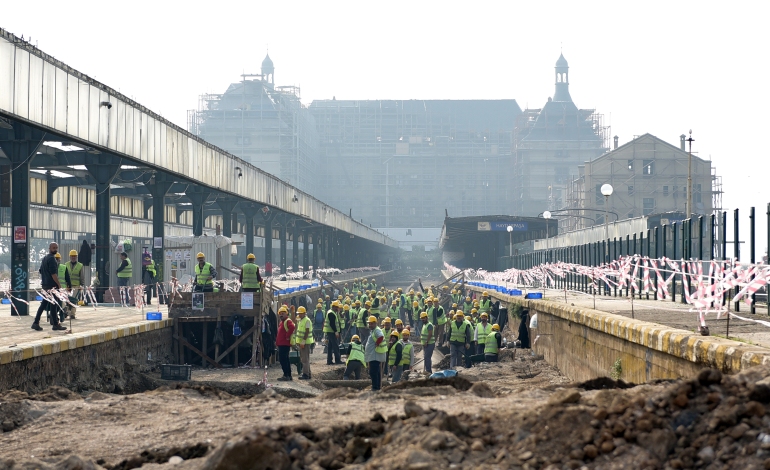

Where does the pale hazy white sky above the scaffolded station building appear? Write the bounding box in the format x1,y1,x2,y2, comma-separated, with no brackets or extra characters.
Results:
0,0,770,246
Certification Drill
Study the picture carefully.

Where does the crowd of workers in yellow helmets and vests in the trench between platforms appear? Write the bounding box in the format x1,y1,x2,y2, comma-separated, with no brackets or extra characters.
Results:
276,279,502,390
